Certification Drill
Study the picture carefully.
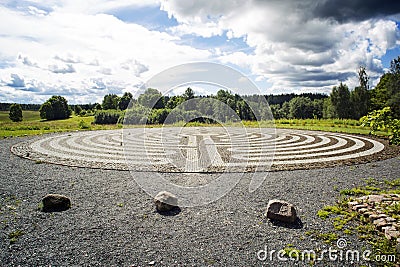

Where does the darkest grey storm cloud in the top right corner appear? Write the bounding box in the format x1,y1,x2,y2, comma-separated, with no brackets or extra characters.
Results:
312,0,400,22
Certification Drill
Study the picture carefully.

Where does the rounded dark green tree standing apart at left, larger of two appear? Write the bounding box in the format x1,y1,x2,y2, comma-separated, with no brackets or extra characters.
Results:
39,96,72,120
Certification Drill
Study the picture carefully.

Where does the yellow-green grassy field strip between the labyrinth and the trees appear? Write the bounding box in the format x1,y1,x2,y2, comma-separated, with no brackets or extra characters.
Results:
0,111,389,137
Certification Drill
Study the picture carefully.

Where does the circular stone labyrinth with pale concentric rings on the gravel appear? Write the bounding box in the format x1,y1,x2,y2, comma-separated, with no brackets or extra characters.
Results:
11,127,392,173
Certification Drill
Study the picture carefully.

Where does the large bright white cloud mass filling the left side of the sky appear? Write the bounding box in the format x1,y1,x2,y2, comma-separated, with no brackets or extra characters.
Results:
0,1,211,103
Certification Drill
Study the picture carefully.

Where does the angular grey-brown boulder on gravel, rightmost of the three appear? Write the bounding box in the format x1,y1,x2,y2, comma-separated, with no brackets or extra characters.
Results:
267,199,297,223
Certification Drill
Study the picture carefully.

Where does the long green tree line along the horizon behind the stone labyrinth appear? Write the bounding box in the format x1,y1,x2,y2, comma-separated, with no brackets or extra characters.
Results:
6,56,400,124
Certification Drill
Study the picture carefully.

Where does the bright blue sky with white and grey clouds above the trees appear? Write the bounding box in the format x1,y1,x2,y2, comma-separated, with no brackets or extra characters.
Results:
0,0,400,104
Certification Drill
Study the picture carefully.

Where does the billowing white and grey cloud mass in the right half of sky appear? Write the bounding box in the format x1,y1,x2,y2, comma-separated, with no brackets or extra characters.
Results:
162,0,400,91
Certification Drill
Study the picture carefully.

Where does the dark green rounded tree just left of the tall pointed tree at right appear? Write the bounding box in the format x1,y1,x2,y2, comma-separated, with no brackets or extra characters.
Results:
331,83,352,119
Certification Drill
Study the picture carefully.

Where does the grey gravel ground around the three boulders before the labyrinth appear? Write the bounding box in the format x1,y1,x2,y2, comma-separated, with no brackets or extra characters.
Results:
0,138,400,266
